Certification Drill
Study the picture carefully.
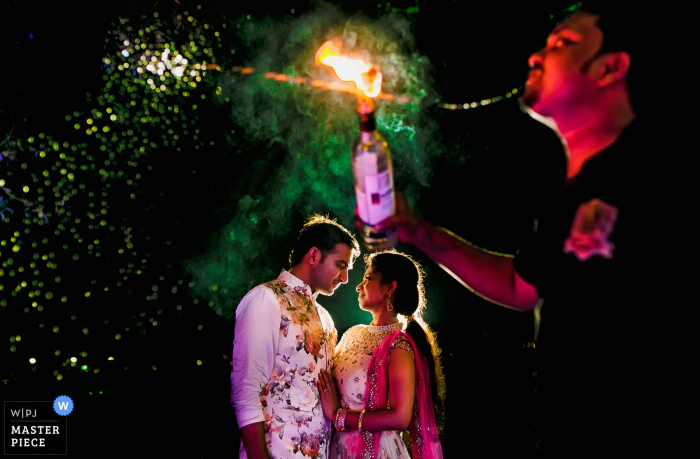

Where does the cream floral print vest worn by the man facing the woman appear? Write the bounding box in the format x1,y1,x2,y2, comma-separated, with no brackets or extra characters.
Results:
260,273,338,459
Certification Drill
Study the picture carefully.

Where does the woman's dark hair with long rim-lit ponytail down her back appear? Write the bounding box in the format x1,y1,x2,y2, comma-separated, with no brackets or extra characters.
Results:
365,249,445,414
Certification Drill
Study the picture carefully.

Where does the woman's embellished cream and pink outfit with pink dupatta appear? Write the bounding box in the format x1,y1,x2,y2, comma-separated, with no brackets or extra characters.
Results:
329,324,442,459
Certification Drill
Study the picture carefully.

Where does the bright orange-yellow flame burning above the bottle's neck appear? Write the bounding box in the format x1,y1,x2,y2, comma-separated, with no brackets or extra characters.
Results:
316,38,382,97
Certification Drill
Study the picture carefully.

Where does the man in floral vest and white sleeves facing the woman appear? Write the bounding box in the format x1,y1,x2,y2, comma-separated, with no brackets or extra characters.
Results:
231,215,360,459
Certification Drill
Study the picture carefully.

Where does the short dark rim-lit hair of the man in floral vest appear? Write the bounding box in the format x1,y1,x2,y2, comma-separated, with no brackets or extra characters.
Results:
289,214,360,266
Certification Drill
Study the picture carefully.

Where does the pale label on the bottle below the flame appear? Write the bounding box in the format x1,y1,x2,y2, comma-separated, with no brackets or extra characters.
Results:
355,170,394,225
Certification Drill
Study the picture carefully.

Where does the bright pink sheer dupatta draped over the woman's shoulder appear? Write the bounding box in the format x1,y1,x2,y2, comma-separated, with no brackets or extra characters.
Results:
361,330,442,459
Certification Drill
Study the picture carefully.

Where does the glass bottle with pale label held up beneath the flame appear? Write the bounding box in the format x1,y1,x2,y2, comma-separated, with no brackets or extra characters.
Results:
351,97,398,251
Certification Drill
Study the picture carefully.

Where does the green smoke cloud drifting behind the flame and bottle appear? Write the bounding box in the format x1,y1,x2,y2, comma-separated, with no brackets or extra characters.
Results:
186,4,437,318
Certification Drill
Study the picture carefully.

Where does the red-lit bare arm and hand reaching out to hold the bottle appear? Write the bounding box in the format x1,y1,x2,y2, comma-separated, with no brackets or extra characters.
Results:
382,193,539,311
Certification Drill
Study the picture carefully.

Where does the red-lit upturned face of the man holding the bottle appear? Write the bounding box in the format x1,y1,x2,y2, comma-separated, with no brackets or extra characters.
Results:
521,13,603,120
